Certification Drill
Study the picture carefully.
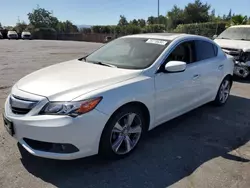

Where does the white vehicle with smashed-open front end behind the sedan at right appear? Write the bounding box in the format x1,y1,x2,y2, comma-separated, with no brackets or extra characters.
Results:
214,25,250,78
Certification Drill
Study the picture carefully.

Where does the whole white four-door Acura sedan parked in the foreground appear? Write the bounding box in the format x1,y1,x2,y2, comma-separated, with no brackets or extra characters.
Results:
3,33,234,160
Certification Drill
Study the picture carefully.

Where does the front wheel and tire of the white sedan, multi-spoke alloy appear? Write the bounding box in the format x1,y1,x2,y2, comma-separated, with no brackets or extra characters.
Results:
99,105,147,159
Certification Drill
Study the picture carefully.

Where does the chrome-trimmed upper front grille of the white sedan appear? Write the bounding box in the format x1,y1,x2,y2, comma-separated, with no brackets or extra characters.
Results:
9,95,38,115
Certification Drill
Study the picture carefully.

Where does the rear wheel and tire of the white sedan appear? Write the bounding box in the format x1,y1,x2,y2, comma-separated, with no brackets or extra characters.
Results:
213,76,232,106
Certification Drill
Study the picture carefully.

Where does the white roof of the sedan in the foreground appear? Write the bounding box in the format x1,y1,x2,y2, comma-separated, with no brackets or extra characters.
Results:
123,33,195,40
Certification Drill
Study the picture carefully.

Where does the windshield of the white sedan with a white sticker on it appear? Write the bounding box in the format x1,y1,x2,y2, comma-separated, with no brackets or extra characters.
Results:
86,38,170,69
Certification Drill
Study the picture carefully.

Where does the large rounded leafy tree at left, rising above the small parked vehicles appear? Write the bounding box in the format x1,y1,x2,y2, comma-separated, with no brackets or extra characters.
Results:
28,6,59,29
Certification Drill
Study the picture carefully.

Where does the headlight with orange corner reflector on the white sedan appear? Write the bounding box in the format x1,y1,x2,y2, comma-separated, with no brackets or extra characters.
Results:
39,97,102,117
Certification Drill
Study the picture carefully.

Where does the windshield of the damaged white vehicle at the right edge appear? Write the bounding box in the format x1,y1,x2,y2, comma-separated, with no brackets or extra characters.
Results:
217,27,250,40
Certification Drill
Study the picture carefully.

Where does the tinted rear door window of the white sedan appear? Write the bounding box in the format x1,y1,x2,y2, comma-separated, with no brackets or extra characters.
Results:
195,40,218,61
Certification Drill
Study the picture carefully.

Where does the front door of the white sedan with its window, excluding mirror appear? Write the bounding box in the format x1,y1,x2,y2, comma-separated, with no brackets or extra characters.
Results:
155,41,202,124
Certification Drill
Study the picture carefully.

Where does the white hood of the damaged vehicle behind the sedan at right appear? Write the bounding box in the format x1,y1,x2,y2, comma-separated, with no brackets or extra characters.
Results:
214,39,250,51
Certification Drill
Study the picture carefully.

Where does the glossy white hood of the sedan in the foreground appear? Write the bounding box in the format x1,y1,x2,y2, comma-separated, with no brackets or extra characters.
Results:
16,60,141,101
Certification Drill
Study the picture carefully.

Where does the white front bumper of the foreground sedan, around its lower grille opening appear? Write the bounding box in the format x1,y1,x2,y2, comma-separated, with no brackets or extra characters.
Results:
4,93,108,160
